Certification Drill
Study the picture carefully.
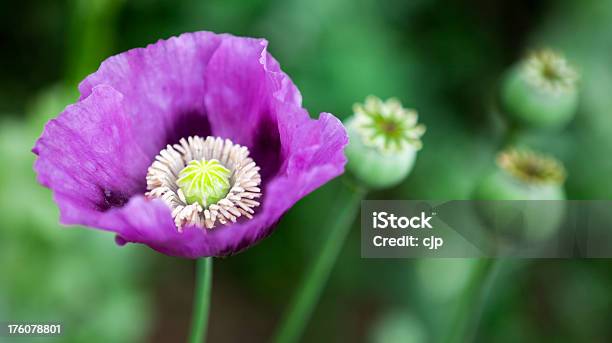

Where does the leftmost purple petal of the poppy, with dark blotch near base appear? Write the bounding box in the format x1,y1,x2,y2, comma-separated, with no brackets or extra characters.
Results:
34,86,151,217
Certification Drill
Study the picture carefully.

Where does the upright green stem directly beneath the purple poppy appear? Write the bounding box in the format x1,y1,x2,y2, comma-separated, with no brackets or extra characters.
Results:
189,257,212,343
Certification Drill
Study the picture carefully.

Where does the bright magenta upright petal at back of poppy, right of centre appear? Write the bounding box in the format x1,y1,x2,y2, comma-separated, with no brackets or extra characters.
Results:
204,37,301,146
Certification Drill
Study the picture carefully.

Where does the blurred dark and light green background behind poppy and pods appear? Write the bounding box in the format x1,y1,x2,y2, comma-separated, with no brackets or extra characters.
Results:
0,0,612,342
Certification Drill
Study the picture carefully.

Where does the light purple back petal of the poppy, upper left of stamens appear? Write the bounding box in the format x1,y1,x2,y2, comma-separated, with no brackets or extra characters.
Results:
79,32,225,157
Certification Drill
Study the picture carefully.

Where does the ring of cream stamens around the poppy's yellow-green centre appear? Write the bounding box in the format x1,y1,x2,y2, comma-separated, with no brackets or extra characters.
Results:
145,136,261,230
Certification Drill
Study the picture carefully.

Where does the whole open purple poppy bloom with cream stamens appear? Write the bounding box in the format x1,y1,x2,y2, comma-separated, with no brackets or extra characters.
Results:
33,32,348,258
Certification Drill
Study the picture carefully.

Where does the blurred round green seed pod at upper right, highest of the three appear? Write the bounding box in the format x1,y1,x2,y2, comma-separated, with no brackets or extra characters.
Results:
500,50,578,128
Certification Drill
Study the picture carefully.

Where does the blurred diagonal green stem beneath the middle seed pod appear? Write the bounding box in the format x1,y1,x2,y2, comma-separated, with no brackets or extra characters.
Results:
273,178,366,343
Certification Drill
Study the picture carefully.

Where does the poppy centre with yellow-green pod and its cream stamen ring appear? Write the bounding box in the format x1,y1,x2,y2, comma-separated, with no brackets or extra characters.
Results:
145,136,261,231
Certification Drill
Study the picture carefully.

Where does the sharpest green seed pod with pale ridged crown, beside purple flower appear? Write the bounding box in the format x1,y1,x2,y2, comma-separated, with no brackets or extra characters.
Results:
345,96,425,189
